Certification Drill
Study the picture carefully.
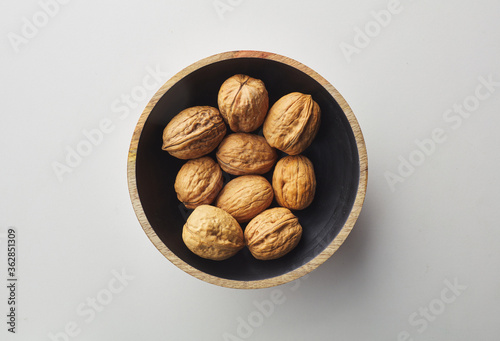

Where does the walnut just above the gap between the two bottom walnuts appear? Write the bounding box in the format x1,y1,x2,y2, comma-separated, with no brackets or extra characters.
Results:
215,175,274,223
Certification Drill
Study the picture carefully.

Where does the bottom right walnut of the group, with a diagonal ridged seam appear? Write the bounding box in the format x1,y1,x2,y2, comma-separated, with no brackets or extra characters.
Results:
245,207,302,260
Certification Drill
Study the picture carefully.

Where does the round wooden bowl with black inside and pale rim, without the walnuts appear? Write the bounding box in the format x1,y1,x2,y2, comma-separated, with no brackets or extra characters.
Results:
127,51,367,288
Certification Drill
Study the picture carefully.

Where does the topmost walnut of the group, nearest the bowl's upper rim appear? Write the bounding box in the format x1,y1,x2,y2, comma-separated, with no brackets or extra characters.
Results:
218,75,269,133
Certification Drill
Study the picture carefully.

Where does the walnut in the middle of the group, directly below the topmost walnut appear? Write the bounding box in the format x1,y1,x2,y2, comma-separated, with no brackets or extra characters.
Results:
216,133,278,175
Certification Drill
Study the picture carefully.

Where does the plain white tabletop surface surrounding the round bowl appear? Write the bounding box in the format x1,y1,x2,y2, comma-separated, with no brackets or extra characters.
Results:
0,0,500,341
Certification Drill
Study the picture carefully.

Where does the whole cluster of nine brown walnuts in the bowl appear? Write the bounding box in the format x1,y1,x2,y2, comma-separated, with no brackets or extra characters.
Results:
162,75,321,260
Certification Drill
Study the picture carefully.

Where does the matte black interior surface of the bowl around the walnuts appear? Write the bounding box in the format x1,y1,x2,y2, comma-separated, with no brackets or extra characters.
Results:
136,58,360,281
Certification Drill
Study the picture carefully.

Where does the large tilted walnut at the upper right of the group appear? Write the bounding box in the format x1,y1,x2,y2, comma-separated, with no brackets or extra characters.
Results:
264,92,321,155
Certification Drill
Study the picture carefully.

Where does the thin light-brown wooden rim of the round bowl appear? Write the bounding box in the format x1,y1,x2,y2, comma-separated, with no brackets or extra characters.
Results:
127,50,368,289
